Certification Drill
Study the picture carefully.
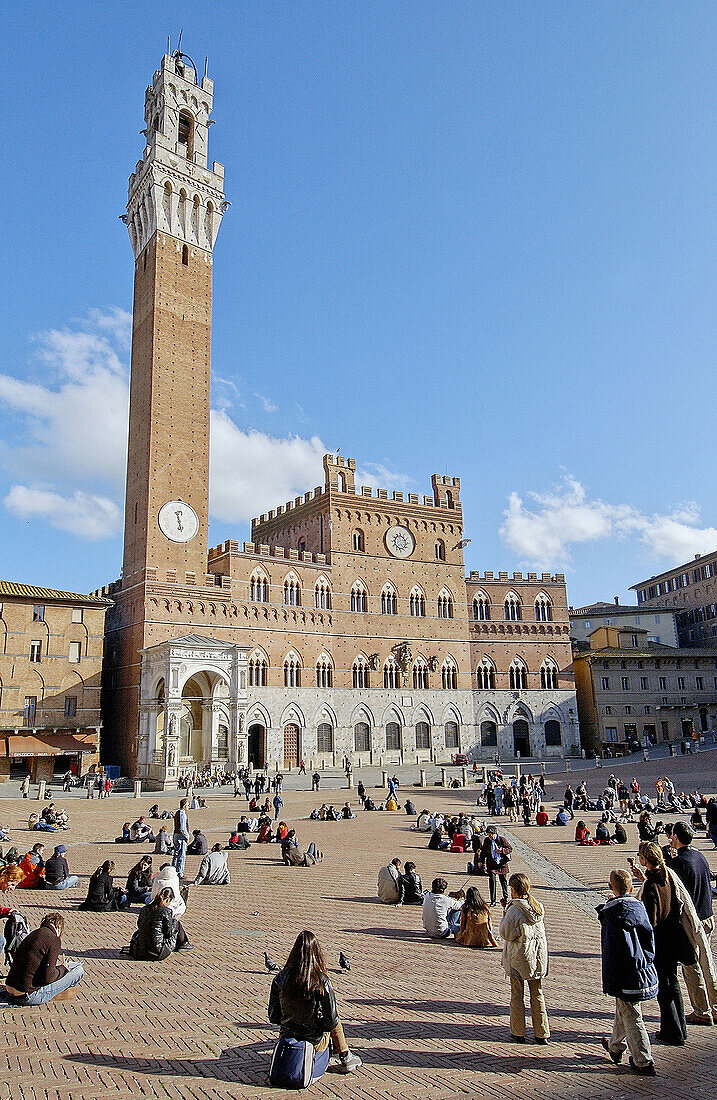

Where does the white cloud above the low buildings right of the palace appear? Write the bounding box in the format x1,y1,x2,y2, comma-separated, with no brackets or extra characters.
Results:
500,476,717,569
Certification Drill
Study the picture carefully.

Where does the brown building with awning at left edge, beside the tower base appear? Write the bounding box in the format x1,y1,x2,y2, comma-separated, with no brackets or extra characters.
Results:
0,581,110,782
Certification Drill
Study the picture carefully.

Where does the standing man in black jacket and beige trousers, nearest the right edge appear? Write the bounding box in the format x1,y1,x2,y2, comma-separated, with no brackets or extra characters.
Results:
670,822,717,1026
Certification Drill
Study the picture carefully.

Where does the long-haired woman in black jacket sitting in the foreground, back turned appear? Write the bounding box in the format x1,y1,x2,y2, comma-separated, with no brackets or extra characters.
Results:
268,932,361,1088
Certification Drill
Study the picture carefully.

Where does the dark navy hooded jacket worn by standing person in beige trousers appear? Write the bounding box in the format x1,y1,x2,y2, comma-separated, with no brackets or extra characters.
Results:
597,894,658,1003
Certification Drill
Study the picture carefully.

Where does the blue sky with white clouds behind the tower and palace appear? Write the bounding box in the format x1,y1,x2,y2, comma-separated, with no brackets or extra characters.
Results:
0,0,717,605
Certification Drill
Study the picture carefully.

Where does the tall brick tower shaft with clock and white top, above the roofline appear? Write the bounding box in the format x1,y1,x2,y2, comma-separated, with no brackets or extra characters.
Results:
122,51,227,592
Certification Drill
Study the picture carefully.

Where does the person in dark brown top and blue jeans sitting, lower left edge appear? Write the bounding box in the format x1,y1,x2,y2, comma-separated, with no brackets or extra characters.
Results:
4,913,84,1007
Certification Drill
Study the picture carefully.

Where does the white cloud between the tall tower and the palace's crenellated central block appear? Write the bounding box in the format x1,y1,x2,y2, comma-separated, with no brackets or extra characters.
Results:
209,410,326,523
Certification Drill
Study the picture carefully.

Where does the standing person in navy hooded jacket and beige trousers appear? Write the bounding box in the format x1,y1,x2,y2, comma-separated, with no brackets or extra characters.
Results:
597,870,658,1077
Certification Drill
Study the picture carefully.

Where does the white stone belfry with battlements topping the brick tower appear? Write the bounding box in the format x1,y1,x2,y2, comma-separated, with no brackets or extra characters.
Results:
123,53,228,260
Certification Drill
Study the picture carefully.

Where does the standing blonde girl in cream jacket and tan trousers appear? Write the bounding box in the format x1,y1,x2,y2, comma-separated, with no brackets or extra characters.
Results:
500,875,550,1045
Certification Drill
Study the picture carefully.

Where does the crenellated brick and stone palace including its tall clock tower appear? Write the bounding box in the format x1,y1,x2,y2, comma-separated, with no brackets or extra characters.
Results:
96,54,578,788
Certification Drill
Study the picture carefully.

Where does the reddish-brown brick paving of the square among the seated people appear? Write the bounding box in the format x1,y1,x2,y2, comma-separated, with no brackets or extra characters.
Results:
0,751,717,1100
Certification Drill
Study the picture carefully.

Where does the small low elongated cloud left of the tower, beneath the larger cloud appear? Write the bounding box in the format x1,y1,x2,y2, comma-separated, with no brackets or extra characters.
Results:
3,485,121,540
